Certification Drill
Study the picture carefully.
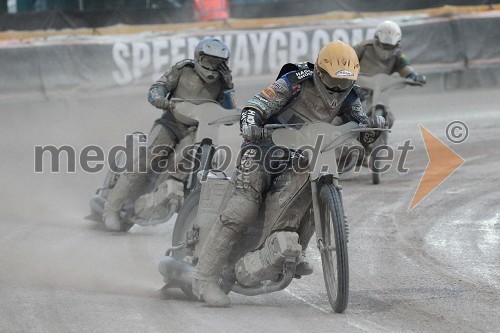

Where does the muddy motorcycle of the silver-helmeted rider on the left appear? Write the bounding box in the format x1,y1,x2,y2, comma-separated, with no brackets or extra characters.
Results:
88,98,240,231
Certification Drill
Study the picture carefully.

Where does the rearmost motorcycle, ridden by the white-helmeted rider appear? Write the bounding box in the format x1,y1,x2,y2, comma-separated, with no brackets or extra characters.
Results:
338,73,423,184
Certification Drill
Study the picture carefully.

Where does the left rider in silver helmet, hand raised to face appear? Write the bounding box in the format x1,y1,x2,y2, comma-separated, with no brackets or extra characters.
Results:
103,38,235,231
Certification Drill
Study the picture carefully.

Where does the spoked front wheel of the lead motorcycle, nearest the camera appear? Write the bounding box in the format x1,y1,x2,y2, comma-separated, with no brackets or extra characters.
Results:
319,184,349,313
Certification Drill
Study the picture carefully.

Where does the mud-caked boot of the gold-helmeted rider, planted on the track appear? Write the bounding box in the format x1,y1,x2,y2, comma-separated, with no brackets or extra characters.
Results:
193,218,240,307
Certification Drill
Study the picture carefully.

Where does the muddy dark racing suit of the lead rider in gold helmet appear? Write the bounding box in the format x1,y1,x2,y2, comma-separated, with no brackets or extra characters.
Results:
193,64,376,306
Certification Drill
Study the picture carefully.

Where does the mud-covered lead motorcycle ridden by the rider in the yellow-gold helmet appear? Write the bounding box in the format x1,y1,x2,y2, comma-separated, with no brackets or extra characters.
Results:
158,122,384,313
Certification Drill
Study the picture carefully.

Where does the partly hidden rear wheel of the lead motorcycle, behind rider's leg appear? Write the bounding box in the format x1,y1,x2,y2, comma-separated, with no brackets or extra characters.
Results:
172,187,201,300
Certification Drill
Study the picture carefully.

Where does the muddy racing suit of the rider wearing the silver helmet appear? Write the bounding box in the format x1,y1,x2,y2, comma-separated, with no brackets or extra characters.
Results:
104,59,235,230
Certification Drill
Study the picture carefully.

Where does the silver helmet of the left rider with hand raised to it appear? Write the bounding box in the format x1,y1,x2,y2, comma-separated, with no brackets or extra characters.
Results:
194,38,229,83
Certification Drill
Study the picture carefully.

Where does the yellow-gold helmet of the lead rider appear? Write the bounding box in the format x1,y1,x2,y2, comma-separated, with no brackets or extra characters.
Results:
314,40,359,108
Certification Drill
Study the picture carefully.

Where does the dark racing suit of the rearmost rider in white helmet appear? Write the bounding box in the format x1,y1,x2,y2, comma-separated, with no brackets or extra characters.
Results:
353,39,425,128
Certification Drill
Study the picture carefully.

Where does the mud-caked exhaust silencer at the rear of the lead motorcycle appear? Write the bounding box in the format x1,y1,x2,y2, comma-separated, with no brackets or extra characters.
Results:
158,256,195,288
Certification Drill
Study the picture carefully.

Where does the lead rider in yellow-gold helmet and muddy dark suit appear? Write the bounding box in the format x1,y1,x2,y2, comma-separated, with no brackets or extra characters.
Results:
193,41,384,306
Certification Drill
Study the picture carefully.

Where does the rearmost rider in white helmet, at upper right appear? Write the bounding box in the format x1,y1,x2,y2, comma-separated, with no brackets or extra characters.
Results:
354,21,426,128
